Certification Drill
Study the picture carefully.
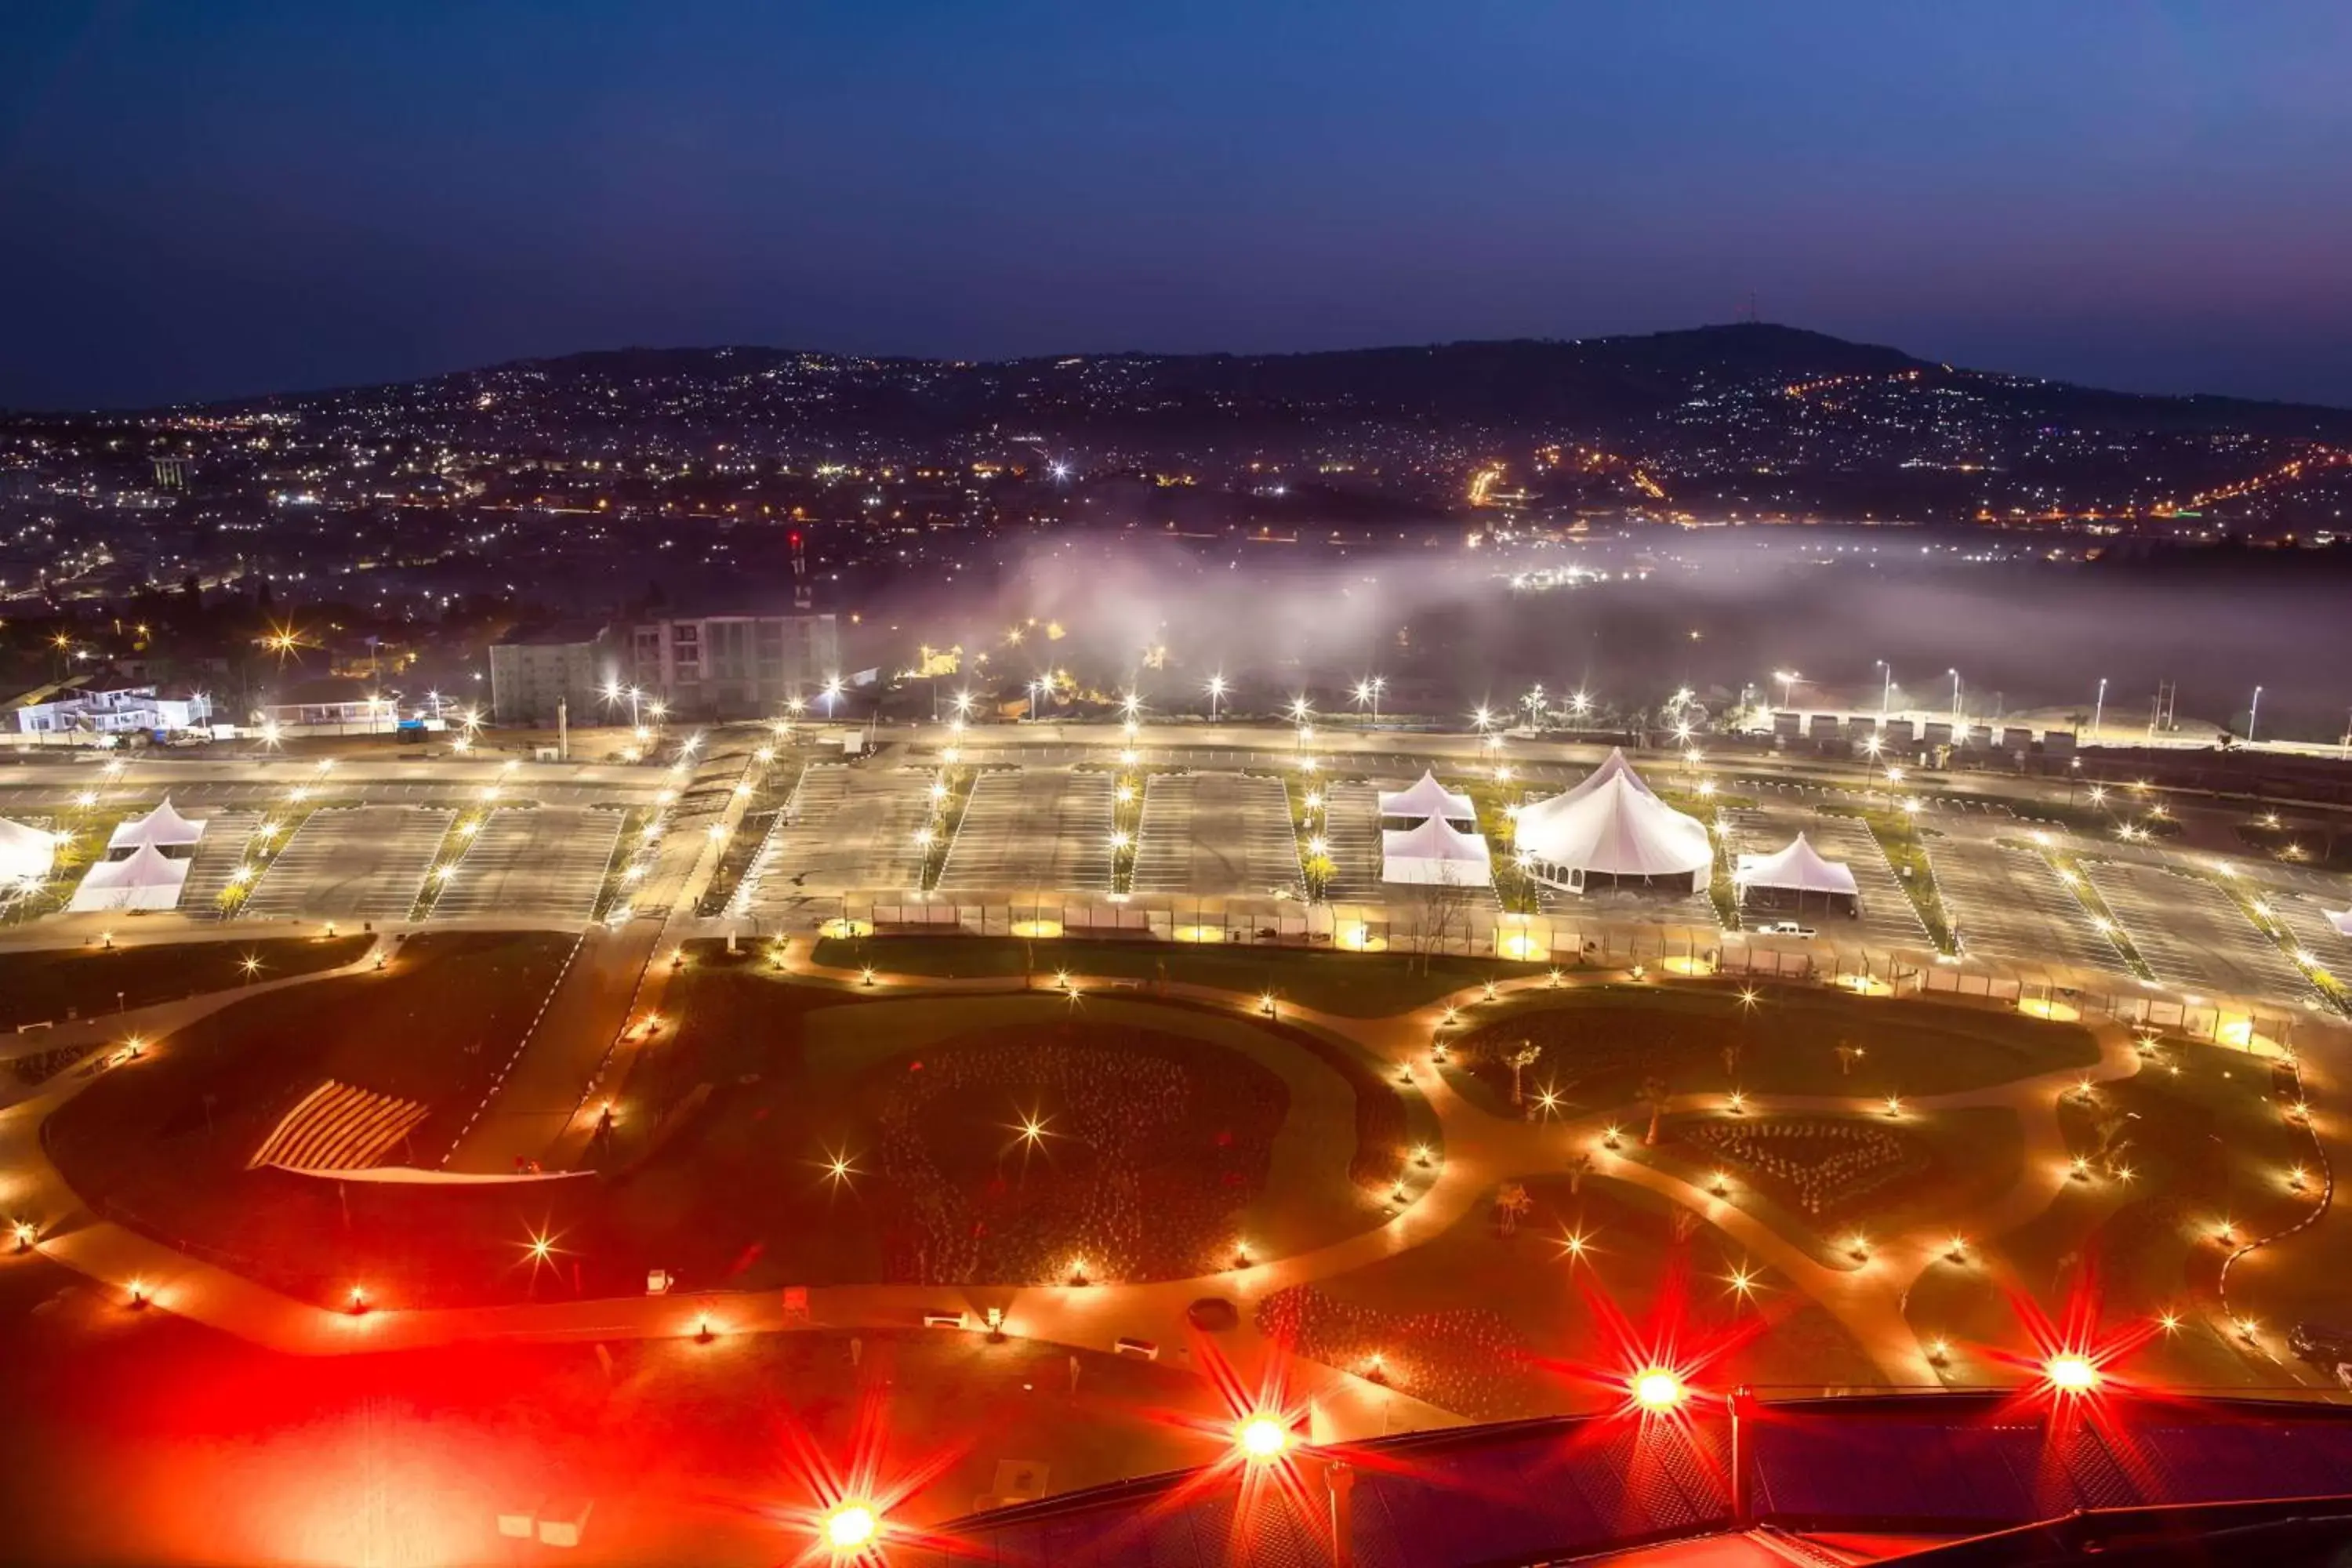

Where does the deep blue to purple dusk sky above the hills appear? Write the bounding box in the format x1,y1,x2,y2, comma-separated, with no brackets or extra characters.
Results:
0,0,2352,407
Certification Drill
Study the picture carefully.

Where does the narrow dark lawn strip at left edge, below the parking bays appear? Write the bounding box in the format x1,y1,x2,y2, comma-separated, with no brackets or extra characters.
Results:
0,935,376,1029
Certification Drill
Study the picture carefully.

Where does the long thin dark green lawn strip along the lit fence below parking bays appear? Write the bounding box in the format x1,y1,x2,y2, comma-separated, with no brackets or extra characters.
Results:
816,935,1538,1018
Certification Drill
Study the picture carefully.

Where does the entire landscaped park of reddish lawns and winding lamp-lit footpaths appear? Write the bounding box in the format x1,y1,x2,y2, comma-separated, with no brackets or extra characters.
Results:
18,933,2352,1427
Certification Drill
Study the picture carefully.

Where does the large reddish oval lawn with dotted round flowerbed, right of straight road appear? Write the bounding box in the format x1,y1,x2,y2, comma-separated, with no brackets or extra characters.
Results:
600,968,1435,1286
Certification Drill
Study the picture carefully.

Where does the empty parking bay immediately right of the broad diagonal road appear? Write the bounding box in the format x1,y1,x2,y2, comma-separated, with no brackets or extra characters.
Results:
741,762,931,916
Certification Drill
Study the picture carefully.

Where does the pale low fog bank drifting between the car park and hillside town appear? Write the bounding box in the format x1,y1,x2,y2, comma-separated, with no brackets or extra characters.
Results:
866,529,2352,739
